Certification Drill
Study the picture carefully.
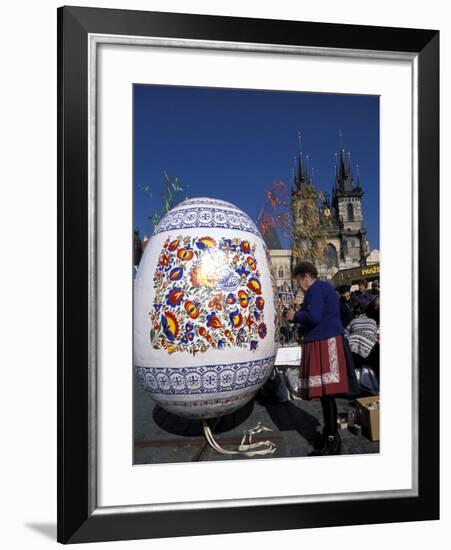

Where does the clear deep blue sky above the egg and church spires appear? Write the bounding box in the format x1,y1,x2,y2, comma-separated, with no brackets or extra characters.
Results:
133,85,379,248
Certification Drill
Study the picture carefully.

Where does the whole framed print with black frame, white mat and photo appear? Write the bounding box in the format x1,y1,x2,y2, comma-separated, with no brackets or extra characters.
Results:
58,7,439,543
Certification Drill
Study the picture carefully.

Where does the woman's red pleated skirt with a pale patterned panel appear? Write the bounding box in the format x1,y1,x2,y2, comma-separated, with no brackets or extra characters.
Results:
298,336,348,399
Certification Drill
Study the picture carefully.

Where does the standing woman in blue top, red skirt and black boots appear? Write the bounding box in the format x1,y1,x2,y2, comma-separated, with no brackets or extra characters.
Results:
287,262,350,455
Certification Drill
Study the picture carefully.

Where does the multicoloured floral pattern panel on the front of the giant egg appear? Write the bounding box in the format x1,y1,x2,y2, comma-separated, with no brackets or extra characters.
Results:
149,235,267,356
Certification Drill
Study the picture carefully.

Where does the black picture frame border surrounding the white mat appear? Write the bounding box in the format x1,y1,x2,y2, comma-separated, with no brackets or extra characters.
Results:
57,7,439,543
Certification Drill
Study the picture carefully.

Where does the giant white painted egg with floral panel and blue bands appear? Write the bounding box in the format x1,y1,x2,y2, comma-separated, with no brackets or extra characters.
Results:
134,198,277,418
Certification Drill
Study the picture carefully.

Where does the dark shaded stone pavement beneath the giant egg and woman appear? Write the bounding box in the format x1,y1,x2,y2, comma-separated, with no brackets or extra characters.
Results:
134,379,379,464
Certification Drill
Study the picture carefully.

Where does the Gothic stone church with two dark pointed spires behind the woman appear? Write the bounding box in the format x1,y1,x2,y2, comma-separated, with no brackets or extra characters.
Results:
264,133,370,292
